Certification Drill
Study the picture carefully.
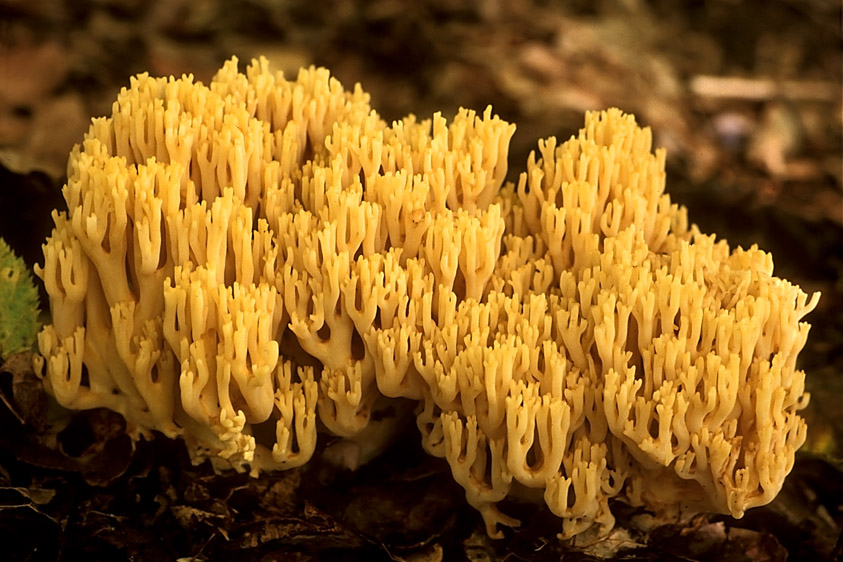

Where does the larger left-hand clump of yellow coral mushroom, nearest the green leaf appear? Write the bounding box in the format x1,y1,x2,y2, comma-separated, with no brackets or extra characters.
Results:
38,55,514,470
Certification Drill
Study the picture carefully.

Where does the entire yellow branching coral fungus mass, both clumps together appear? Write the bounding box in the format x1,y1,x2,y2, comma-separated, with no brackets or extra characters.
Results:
37,59,819,537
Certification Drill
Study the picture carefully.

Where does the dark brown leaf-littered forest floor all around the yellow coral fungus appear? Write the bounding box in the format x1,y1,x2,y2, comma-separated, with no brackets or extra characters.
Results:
0,0,843,560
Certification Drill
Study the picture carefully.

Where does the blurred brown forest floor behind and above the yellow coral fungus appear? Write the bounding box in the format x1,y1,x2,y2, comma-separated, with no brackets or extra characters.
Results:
0,0,843,548
